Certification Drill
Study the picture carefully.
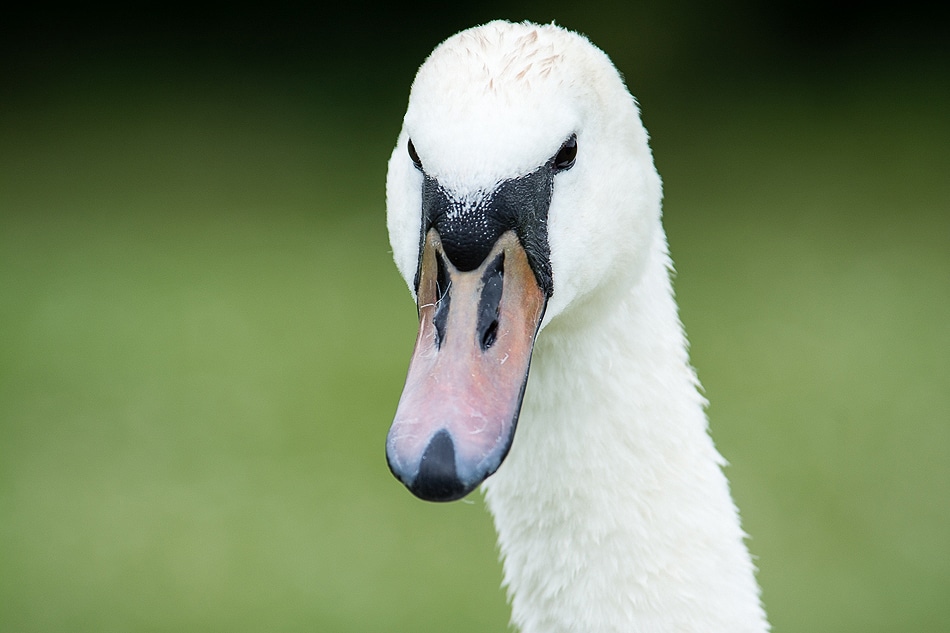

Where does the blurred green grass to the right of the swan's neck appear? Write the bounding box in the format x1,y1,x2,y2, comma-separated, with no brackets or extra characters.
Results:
654,74,950,631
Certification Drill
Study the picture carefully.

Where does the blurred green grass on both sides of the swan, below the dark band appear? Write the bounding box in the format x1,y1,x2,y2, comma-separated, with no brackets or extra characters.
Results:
0,60,950,632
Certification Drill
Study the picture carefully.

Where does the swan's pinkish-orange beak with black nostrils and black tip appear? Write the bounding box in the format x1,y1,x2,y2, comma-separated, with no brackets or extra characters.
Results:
386,229,547,501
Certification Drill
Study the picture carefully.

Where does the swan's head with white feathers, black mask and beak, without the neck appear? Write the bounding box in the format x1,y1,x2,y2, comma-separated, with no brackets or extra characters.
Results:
387,22,660,501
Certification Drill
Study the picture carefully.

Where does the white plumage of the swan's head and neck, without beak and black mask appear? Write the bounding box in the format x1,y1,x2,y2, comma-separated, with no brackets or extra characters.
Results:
387,22,768,633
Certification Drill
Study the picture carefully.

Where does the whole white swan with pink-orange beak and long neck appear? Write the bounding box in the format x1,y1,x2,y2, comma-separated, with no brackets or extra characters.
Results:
386,22,768,633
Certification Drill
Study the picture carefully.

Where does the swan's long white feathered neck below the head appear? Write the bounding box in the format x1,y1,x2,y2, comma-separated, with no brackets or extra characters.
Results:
484,229,768,633
